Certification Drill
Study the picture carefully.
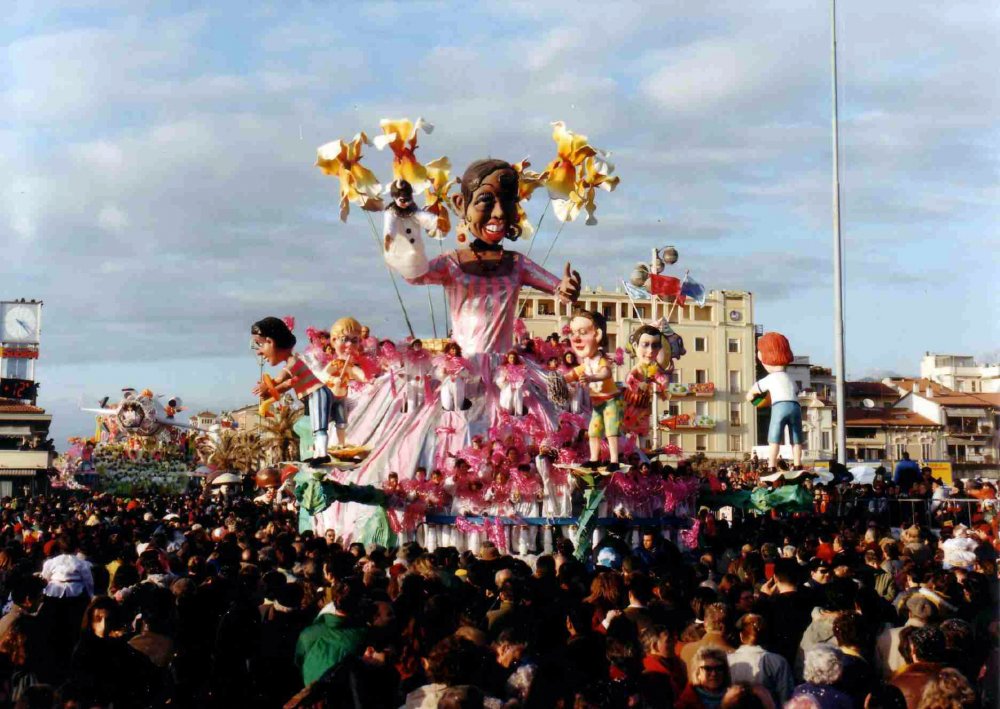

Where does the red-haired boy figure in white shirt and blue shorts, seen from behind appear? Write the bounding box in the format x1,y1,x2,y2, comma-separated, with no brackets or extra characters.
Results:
746,332,802,471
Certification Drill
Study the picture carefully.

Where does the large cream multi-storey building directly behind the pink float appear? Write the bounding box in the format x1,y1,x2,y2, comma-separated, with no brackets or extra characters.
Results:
520,288,759,458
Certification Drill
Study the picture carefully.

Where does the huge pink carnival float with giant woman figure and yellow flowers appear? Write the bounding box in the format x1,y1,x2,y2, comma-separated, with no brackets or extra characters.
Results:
242,119,704,557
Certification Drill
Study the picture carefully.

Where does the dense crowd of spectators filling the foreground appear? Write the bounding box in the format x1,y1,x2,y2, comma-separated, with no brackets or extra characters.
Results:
0,476,988,709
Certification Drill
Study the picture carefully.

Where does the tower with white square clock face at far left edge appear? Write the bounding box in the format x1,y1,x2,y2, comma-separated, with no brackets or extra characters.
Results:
0,298,42,404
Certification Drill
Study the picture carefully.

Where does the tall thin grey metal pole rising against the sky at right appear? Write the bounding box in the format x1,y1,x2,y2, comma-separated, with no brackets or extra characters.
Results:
830,0,847,464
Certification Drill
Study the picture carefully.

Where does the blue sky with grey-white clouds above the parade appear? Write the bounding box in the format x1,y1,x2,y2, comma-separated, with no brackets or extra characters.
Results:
0,0,1000,443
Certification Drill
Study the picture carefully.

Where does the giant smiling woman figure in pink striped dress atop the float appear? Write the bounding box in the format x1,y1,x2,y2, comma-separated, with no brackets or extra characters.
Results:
325,159,580,544
